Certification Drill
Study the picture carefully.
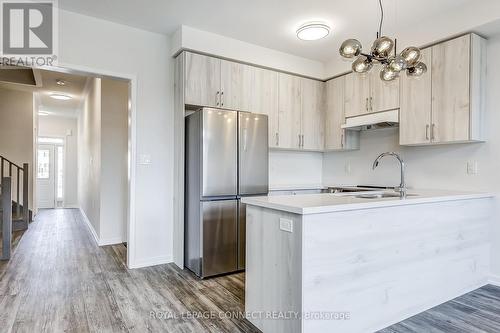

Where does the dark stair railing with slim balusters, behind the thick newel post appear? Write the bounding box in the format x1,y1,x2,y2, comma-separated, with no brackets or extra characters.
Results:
0,156,29,228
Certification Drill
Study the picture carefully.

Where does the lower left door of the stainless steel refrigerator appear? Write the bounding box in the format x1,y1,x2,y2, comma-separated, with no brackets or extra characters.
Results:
202,200,238,277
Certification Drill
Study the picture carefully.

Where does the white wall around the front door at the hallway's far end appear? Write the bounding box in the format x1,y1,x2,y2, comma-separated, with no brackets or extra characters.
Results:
38,115,78,207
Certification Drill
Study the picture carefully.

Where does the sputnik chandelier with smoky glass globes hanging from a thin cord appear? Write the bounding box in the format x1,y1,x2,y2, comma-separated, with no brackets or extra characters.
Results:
339,0,427,81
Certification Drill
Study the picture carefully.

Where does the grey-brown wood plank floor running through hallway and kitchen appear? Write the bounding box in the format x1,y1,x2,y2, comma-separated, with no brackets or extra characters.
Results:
0,209,500,333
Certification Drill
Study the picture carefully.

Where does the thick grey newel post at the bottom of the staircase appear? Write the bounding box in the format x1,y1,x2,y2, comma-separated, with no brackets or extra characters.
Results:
0,177,12,260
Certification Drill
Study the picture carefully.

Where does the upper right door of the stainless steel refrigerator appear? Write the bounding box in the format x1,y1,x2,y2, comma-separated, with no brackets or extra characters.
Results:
238,112,269,195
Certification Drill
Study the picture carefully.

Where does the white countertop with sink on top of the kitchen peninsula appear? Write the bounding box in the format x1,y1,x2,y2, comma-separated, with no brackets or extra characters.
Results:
242,190,493,215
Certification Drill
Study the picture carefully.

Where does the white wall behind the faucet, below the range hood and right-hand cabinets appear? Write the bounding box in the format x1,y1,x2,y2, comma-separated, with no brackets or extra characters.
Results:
323,37,500,281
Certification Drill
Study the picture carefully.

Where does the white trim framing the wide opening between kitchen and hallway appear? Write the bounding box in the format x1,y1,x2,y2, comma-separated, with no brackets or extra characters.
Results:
43,62,137,268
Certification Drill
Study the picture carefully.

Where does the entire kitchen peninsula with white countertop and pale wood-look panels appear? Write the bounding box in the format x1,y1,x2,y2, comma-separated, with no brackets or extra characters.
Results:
243,191,492,333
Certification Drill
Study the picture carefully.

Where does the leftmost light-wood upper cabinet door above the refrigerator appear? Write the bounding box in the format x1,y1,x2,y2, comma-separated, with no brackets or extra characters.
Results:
184,52,220,106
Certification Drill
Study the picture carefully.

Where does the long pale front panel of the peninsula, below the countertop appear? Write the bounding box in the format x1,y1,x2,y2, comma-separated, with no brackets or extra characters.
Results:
303,199,491,333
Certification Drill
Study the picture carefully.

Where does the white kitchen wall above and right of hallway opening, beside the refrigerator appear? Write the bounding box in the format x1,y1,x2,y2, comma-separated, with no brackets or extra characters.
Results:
59,10,173,267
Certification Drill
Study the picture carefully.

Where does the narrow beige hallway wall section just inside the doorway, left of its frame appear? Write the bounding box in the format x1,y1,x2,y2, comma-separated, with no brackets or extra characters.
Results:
99,79,129,244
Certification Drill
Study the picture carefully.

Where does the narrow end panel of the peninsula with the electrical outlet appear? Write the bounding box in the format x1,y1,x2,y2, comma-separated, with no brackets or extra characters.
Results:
245,205,302,333
